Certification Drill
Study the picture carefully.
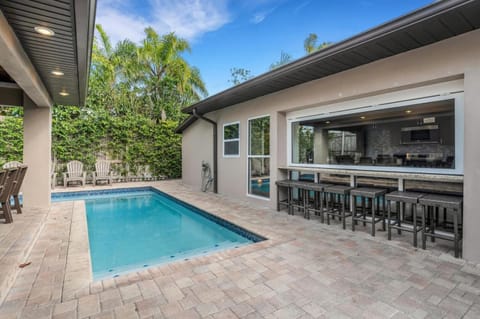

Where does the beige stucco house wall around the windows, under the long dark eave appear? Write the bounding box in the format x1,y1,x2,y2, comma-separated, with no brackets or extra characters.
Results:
183,30,480,261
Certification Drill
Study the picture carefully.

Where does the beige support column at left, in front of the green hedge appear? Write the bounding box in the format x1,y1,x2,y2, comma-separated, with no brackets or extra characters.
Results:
22,95,52,208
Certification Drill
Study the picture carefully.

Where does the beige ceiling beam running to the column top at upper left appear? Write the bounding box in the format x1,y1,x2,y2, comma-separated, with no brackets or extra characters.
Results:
0,11,53,107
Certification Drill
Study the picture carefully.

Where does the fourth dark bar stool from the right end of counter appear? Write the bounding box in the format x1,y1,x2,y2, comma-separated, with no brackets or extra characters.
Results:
324,185,353,229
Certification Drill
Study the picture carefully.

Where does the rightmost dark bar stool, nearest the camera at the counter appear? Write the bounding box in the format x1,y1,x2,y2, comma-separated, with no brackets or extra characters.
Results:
419,194,463,258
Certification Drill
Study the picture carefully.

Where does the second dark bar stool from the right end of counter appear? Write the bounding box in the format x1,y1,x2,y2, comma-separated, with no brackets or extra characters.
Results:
385,191,425,247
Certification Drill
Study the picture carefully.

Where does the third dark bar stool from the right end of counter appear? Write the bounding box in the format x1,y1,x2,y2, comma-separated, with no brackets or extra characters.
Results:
350,187,387,236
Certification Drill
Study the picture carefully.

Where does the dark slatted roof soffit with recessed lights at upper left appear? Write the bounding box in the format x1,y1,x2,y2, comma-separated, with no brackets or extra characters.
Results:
0,0,96,105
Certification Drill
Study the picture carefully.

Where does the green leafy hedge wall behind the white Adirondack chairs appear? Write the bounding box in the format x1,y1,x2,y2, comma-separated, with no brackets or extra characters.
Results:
0,106,182,178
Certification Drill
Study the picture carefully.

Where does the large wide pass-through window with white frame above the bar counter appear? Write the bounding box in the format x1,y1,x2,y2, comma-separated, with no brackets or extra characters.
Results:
290,94,463,172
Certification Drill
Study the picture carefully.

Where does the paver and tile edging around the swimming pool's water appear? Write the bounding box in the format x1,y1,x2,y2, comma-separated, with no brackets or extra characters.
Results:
62,186,276,302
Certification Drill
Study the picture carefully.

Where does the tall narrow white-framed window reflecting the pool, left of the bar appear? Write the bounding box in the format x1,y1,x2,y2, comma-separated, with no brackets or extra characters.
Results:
248,116,270,198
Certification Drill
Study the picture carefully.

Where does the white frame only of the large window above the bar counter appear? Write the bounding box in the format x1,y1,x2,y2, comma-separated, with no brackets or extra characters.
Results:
287,91,465,175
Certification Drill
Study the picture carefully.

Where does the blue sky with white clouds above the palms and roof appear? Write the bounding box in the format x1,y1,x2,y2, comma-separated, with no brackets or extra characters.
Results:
96,0,433,95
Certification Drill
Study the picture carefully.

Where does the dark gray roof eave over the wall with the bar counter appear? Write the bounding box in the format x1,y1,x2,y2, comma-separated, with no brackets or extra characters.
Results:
177,0,480,133
